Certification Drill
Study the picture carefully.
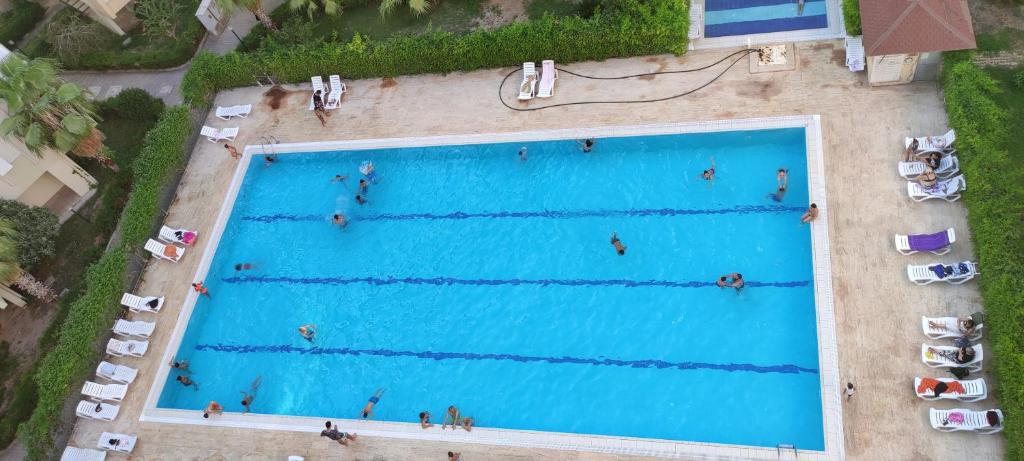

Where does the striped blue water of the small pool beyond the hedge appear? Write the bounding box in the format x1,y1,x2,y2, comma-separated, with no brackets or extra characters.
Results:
705,0,828,37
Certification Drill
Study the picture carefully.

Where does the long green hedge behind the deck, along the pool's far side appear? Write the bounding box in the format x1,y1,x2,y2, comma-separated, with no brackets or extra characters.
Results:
181,0,689,104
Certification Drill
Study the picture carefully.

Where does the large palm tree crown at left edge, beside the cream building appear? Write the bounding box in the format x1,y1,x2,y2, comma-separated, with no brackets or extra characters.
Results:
0,53,114,168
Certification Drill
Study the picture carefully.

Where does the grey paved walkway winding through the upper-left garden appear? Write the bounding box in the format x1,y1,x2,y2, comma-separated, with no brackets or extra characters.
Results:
62,0,285,106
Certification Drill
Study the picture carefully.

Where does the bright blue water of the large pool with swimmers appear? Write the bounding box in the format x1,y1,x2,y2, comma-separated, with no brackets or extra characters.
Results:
159,128,823,450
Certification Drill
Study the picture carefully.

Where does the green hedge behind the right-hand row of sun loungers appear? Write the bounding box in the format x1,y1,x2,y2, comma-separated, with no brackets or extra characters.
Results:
942,57,1024,459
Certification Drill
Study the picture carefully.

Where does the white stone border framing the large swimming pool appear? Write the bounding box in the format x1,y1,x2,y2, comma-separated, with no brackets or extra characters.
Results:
139,115,845,461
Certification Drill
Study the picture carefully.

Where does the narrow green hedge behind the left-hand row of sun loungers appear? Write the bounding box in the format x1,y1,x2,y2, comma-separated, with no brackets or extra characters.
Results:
18,106,193,460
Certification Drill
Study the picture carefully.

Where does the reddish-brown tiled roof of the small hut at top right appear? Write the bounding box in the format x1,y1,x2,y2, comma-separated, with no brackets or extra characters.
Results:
860,0,977,56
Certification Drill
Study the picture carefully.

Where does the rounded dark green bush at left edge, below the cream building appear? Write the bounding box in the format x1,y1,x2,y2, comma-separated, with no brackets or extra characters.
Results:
0,200,57,270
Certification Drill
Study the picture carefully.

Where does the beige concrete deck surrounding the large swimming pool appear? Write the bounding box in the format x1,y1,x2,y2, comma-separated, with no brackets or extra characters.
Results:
71,41,1004,461
